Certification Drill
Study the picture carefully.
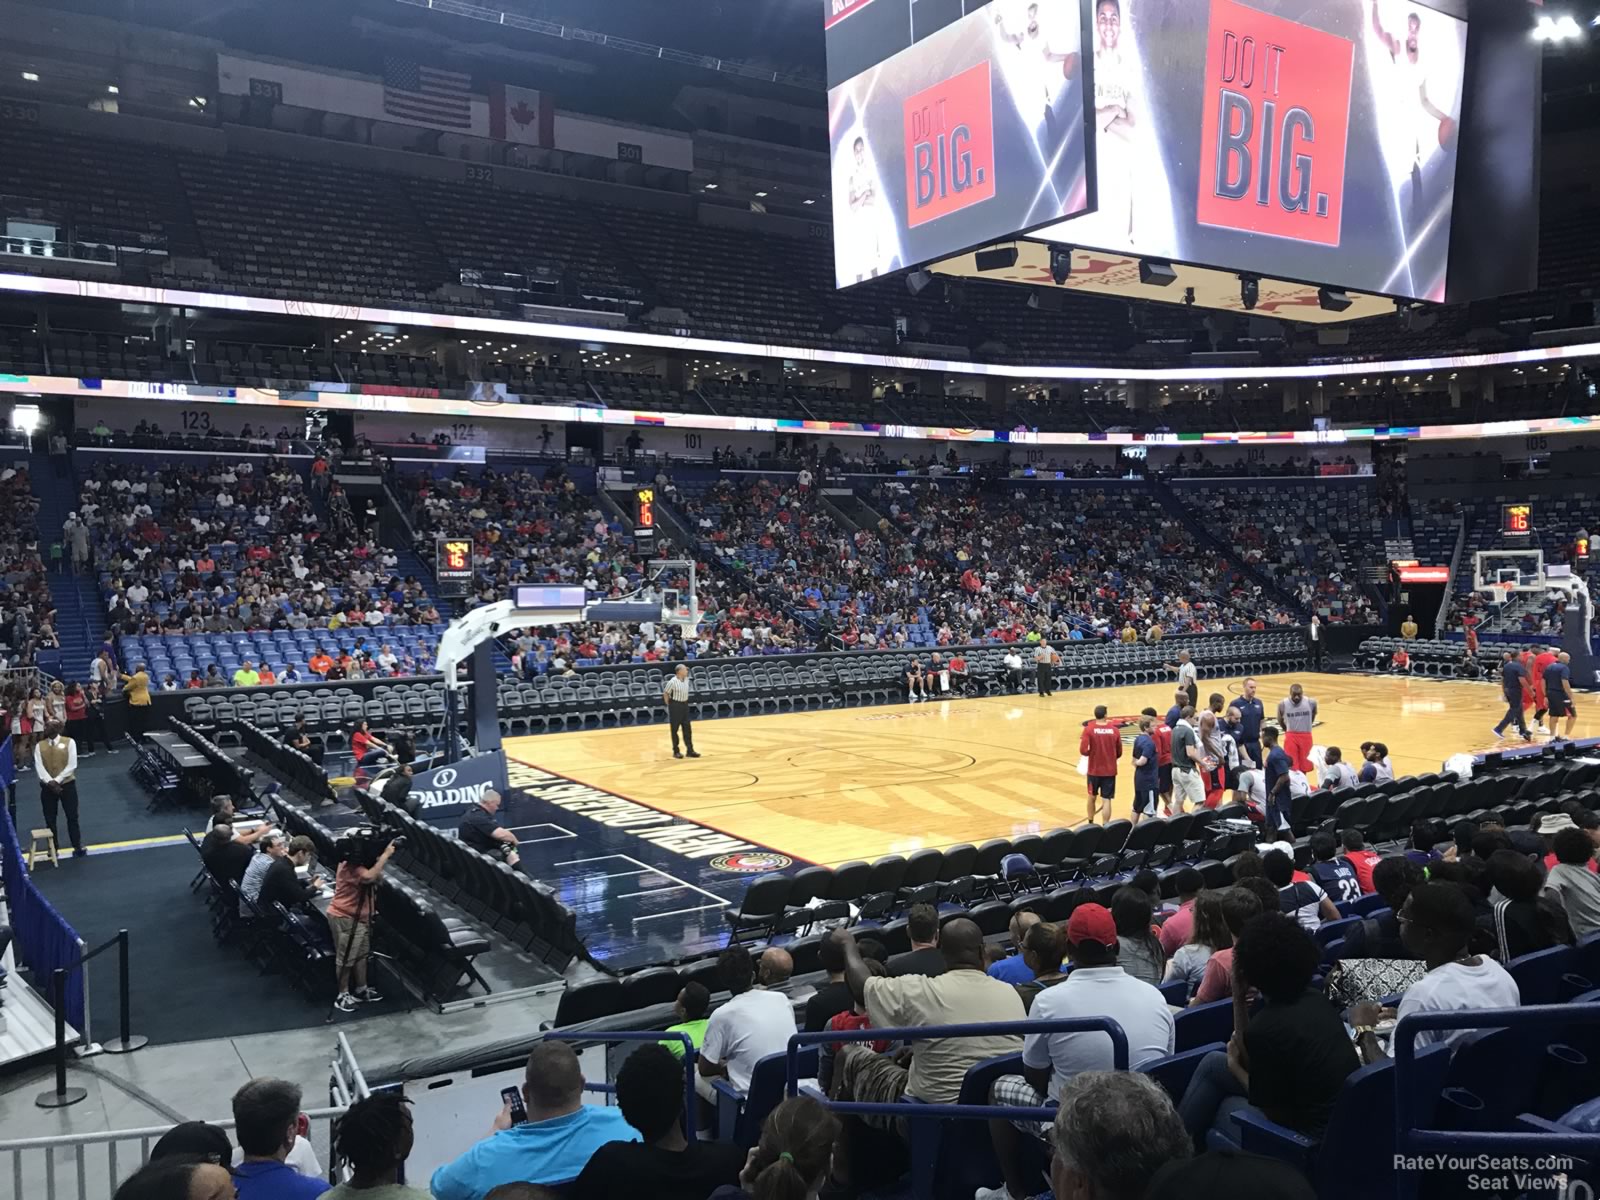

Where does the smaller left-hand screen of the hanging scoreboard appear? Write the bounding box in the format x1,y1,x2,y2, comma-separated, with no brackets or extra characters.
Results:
826,0,1093,288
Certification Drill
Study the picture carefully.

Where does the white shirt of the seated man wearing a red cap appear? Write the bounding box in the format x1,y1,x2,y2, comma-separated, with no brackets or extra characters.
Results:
1022,966,1173,1099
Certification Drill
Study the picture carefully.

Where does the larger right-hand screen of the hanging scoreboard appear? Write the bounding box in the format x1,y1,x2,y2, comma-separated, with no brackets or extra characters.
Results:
1038,0,1467,301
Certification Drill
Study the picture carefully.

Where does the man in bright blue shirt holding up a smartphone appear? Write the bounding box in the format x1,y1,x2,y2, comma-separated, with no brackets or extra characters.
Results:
430,1042,643,1200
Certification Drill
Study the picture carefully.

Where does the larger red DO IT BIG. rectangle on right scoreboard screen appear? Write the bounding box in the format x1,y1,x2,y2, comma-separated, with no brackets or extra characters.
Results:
1197,0,1355,246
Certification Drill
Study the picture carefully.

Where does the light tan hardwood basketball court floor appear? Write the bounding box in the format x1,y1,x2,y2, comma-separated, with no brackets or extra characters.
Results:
506,672,1600,864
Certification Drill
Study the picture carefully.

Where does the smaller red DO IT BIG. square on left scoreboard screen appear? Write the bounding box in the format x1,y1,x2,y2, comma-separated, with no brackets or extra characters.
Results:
906,62,995,227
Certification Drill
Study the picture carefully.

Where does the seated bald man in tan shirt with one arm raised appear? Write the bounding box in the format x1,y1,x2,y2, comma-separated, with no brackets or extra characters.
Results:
829,917,1026,1131
